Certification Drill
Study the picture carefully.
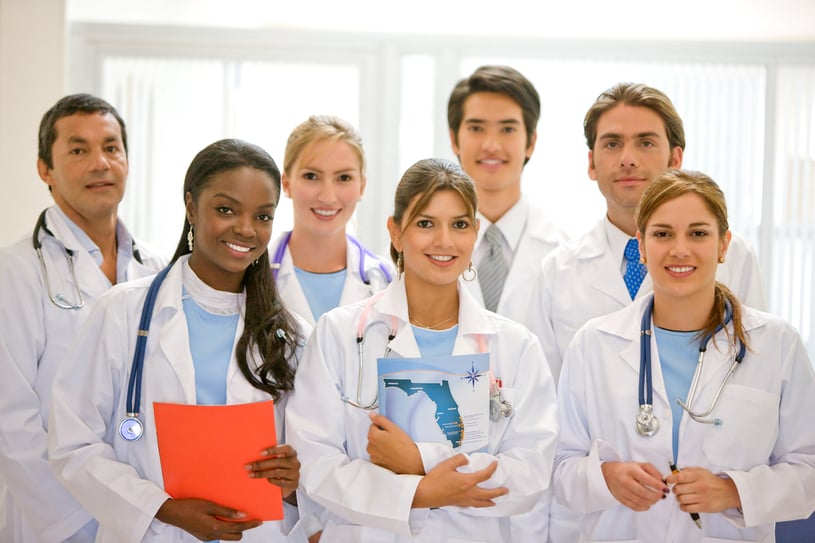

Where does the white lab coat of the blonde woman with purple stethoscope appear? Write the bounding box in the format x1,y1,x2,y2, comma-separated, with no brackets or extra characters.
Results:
269,233,396,326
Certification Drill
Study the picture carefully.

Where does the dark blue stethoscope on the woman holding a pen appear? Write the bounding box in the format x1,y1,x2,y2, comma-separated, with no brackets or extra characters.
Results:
637,297,747,437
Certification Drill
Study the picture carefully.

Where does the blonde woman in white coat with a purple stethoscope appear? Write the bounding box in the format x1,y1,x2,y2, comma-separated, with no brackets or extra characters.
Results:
269,115,395,326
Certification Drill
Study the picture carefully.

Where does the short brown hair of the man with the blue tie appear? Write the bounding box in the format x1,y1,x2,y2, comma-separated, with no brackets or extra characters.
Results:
583,83,685,151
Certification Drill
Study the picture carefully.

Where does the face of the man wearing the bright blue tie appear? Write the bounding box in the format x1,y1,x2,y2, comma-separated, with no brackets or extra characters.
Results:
589,104,682,232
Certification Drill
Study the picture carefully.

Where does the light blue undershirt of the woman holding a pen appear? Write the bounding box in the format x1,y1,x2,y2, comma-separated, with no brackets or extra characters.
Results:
654,326,699,463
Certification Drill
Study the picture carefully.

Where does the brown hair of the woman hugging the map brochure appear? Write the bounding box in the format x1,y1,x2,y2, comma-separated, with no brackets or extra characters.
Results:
390,158,478,272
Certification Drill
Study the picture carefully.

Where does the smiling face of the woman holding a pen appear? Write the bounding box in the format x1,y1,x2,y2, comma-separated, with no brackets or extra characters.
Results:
637,192,730,304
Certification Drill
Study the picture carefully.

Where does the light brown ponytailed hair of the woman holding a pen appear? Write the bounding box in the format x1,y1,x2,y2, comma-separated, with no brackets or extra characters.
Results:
634,170,749,347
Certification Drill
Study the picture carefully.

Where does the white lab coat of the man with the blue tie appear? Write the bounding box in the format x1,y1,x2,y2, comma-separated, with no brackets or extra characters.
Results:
523,219,765,382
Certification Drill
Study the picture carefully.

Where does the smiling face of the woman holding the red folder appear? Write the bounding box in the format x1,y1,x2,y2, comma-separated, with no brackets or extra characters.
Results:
186,166,277,292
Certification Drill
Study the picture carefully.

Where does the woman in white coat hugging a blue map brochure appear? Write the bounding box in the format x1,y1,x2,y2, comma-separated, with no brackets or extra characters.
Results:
286,159,557,542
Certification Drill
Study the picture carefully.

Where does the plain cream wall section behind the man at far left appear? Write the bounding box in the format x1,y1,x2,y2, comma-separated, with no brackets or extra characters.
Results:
0,0,66,245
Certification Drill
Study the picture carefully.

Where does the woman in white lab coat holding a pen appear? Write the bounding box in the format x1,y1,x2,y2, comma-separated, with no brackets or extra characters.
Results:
553,171,815,543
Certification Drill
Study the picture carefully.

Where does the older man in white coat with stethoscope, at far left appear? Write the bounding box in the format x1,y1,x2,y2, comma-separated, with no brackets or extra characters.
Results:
0,94,166,543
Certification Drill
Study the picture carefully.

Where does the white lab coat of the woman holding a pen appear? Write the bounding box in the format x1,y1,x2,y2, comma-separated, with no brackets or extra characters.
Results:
553,297,815,543
